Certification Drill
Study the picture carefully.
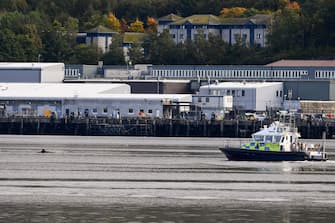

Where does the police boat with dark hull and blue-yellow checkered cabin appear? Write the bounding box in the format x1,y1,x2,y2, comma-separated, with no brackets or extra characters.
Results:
220,113,327,161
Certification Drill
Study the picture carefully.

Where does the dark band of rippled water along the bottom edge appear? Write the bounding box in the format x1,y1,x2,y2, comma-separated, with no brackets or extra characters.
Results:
0,203,335,223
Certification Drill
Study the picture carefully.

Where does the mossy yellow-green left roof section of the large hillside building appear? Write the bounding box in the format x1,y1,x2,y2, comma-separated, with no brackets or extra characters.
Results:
171,14,221,25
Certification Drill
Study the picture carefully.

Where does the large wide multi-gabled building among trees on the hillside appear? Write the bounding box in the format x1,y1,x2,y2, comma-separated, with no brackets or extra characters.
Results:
158,14,271,47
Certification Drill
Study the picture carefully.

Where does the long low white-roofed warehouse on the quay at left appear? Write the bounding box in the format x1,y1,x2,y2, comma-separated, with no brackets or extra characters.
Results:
0,83,192,118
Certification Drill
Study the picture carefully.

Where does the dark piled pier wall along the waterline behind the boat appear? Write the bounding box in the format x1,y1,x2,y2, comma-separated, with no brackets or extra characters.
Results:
0,117,335,139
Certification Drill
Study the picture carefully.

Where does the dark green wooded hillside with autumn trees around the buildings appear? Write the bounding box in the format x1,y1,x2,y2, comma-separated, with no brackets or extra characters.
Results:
0,0,335,64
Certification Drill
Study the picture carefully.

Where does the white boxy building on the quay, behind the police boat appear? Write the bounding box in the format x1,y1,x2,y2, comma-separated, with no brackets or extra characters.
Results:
199,82,284,111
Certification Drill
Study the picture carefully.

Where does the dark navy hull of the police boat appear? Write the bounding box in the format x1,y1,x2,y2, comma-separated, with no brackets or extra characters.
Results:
220,148,309,161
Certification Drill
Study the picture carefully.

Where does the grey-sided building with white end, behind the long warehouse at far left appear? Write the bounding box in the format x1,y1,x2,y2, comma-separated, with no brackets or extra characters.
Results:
0,62,64,83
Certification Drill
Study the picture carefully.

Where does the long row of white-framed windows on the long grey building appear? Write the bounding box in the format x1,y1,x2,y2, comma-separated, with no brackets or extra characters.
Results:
151,70,308,79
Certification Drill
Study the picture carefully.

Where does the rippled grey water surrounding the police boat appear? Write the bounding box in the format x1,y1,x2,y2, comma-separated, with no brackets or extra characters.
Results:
0,136,335,223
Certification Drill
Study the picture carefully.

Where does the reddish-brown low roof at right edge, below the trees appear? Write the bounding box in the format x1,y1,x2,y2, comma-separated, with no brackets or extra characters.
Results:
266,60,335,67
